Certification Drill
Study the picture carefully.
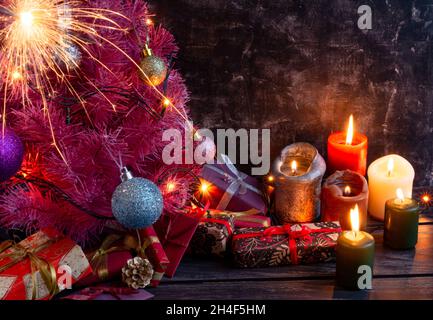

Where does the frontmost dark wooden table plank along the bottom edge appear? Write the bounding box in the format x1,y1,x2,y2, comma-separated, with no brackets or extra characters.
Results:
149,277,433,300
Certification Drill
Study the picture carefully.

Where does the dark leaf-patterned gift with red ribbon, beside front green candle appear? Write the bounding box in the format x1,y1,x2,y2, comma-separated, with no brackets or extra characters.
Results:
232,222,341,268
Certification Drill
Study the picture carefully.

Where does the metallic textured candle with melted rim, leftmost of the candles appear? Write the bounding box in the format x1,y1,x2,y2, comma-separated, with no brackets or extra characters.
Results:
273,142,326,223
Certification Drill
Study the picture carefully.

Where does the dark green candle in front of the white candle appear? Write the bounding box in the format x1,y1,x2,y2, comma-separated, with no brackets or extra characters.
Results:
383,189,420,249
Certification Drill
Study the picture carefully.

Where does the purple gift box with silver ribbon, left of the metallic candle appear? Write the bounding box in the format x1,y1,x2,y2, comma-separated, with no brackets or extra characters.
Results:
201,155,267,214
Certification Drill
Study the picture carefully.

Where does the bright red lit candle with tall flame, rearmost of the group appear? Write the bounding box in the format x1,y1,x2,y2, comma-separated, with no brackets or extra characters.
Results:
327,115,368,176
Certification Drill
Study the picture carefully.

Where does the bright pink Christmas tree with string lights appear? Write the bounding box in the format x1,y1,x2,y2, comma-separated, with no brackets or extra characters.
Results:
0,0,199,243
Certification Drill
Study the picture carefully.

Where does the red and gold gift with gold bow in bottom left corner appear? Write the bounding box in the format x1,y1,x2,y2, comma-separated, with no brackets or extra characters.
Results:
0,228,92,300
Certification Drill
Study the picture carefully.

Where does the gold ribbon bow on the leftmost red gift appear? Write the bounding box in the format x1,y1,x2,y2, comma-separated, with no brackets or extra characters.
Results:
0,239,59,300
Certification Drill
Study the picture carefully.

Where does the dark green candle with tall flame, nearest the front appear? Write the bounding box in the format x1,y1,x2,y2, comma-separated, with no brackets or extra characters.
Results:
336,205,374,289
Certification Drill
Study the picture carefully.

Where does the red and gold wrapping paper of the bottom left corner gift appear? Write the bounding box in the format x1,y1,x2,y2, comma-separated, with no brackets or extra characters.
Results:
0,228,92,300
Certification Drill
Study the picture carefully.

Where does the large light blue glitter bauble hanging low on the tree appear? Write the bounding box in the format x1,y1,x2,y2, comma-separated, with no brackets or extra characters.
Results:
111,168,164,229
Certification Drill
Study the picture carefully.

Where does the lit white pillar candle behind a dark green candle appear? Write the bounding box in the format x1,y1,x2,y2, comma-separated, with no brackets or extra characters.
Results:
367,154,415,220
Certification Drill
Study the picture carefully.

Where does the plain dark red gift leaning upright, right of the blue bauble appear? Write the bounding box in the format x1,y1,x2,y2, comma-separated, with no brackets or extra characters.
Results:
154,213,200,277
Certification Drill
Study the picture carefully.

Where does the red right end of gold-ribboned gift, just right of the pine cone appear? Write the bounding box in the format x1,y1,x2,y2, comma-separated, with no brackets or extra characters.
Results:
140,227,170,287
